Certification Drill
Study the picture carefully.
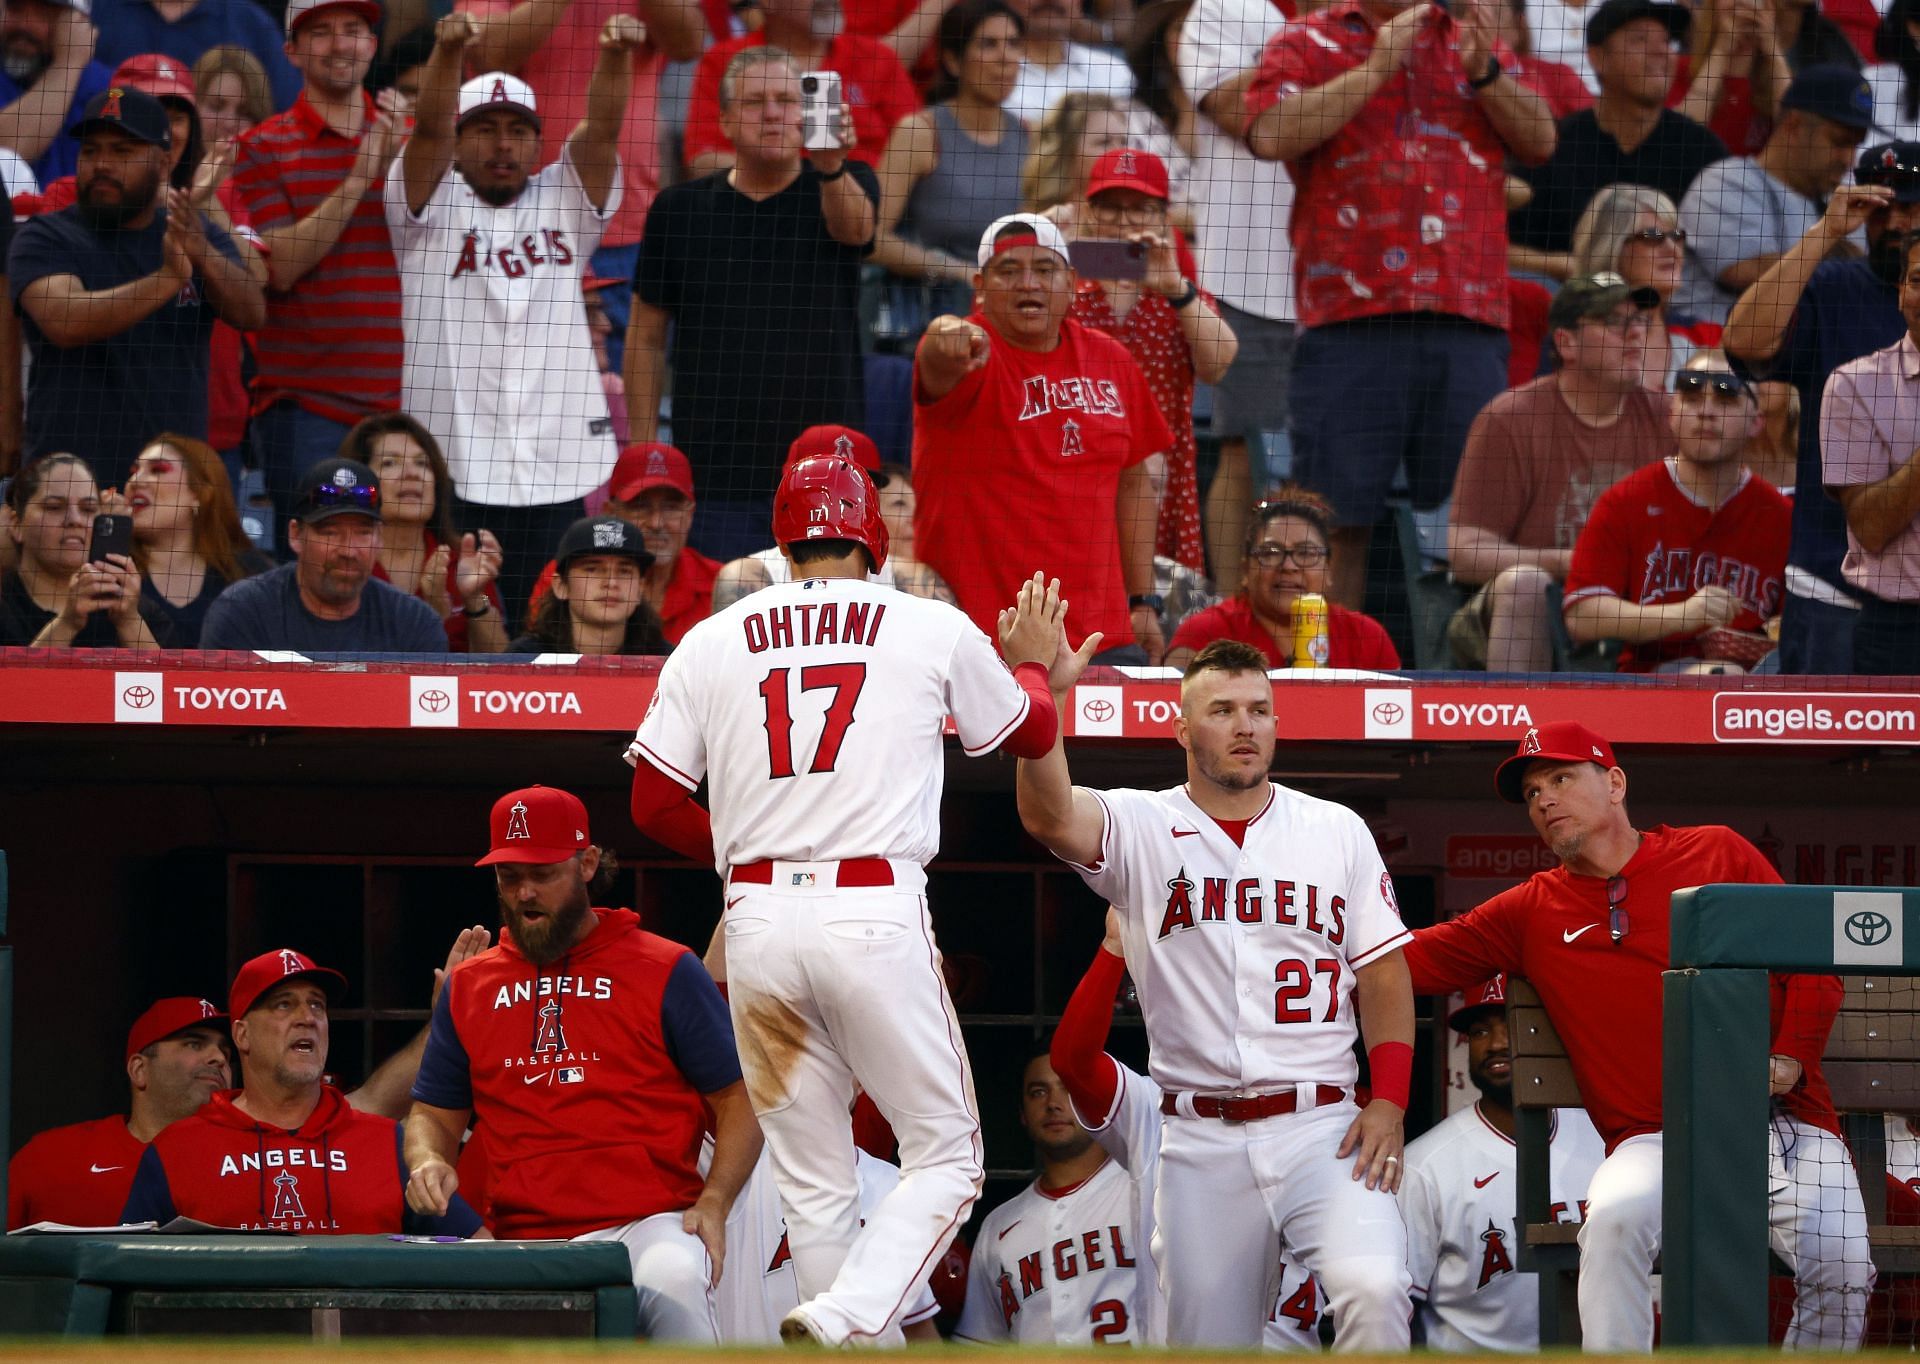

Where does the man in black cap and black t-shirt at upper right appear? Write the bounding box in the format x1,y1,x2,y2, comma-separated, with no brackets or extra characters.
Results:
1507,0,1726,279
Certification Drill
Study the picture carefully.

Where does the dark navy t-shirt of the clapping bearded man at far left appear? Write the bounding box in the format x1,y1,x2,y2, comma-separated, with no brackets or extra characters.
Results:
6,207,240,470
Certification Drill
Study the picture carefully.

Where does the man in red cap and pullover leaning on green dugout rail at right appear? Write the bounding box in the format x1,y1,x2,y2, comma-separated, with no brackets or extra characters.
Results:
1405,720,1874,1352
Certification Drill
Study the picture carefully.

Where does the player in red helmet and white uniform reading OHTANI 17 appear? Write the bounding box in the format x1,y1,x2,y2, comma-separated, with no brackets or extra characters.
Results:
628,459,1062,1345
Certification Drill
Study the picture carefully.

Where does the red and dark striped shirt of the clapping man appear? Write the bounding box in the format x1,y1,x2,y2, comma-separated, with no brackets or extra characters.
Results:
232,92,403,423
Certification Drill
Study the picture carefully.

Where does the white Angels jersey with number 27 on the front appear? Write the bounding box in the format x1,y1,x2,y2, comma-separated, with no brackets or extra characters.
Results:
1075,784,1413,1093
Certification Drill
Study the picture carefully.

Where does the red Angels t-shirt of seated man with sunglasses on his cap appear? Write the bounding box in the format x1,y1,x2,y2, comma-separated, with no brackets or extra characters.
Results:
1567,457,1793,672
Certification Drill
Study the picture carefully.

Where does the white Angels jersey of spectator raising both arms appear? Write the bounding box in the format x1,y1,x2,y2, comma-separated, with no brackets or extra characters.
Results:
386,150,620,507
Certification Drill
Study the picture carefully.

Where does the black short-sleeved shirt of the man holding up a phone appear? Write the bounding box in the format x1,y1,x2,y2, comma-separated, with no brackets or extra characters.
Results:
634,161,879,499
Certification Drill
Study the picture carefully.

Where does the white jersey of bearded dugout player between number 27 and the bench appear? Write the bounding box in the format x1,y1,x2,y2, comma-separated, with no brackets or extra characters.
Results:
1400,1105,1607,1354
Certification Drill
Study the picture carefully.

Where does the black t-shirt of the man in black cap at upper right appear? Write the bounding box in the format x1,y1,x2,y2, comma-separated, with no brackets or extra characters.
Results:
1507,110,1726,252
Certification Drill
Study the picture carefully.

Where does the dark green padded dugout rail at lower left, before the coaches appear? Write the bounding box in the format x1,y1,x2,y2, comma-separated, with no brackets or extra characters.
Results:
0,1233,639,1341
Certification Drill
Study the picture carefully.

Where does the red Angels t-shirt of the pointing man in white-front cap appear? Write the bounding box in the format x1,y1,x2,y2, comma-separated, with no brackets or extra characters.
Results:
914,313,1173,647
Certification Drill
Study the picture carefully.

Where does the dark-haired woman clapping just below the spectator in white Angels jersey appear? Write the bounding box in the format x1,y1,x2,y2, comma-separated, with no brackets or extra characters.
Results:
340,411,507,653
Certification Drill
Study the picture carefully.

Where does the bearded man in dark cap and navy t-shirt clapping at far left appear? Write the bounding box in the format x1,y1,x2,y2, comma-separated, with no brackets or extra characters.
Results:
8,85,267,469
